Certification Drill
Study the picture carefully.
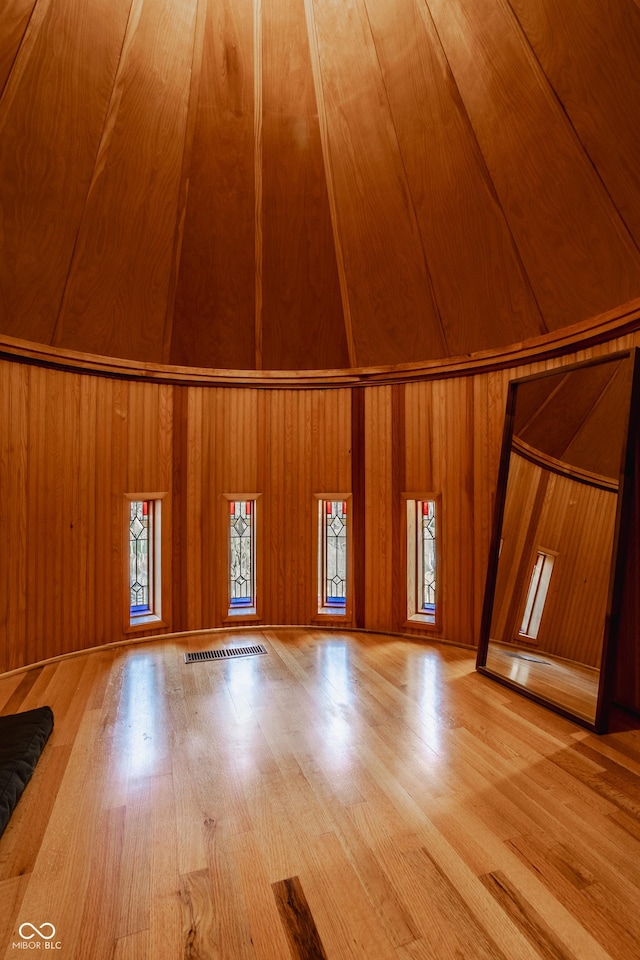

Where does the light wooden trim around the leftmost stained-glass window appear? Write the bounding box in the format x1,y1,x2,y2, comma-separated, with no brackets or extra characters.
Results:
122,491,168,633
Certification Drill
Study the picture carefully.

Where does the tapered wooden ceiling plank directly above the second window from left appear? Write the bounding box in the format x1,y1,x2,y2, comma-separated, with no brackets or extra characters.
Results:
171,0,256,369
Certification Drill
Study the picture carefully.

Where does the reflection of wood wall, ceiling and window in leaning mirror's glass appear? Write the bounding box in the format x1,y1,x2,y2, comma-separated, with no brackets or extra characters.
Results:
478,354,632,725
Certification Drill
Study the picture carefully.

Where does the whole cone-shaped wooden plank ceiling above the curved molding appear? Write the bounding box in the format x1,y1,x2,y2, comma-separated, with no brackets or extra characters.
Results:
0,0,640,370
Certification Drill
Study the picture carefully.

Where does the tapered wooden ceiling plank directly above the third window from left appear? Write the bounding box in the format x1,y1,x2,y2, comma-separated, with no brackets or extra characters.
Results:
262,0,349,369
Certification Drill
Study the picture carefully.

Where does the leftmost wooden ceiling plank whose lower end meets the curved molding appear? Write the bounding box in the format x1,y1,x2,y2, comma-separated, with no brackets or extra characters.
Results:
0,0,131,343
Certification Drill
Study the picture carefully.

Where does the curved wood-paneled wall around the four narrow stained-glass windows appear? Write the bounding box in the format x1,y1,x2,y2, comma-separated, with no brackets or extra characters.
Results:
0,337,640,670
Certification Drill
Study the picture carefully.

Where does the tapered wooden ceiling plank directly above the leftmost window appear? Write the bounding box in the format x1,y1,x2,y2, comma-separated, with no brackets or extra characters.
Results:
55,0,197,360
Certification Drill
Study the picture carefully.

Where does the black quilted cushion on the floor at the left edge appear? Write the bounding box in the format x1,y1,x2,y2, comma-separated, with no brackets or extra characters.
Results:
0,707,53,836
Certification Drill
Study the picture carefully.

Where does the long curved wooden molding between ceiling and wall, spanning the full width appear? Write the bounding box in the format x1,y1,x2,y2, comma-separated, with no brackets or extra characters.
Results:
0,298,640,390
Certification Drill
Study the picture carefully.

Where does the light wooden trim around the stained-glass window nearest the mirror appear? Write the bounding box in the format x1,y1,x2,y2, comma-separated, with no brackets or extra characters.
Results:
402,491,443,631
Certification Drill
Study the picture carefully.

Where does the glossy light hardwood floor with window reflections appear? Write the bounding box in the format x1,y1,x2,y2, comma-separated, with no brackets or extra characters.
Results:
0,629,640,960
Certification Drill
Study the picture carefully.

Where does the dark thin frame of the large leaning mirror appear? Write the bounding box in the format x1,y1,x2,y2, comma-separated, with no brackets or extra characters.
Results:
476,347,640,733
